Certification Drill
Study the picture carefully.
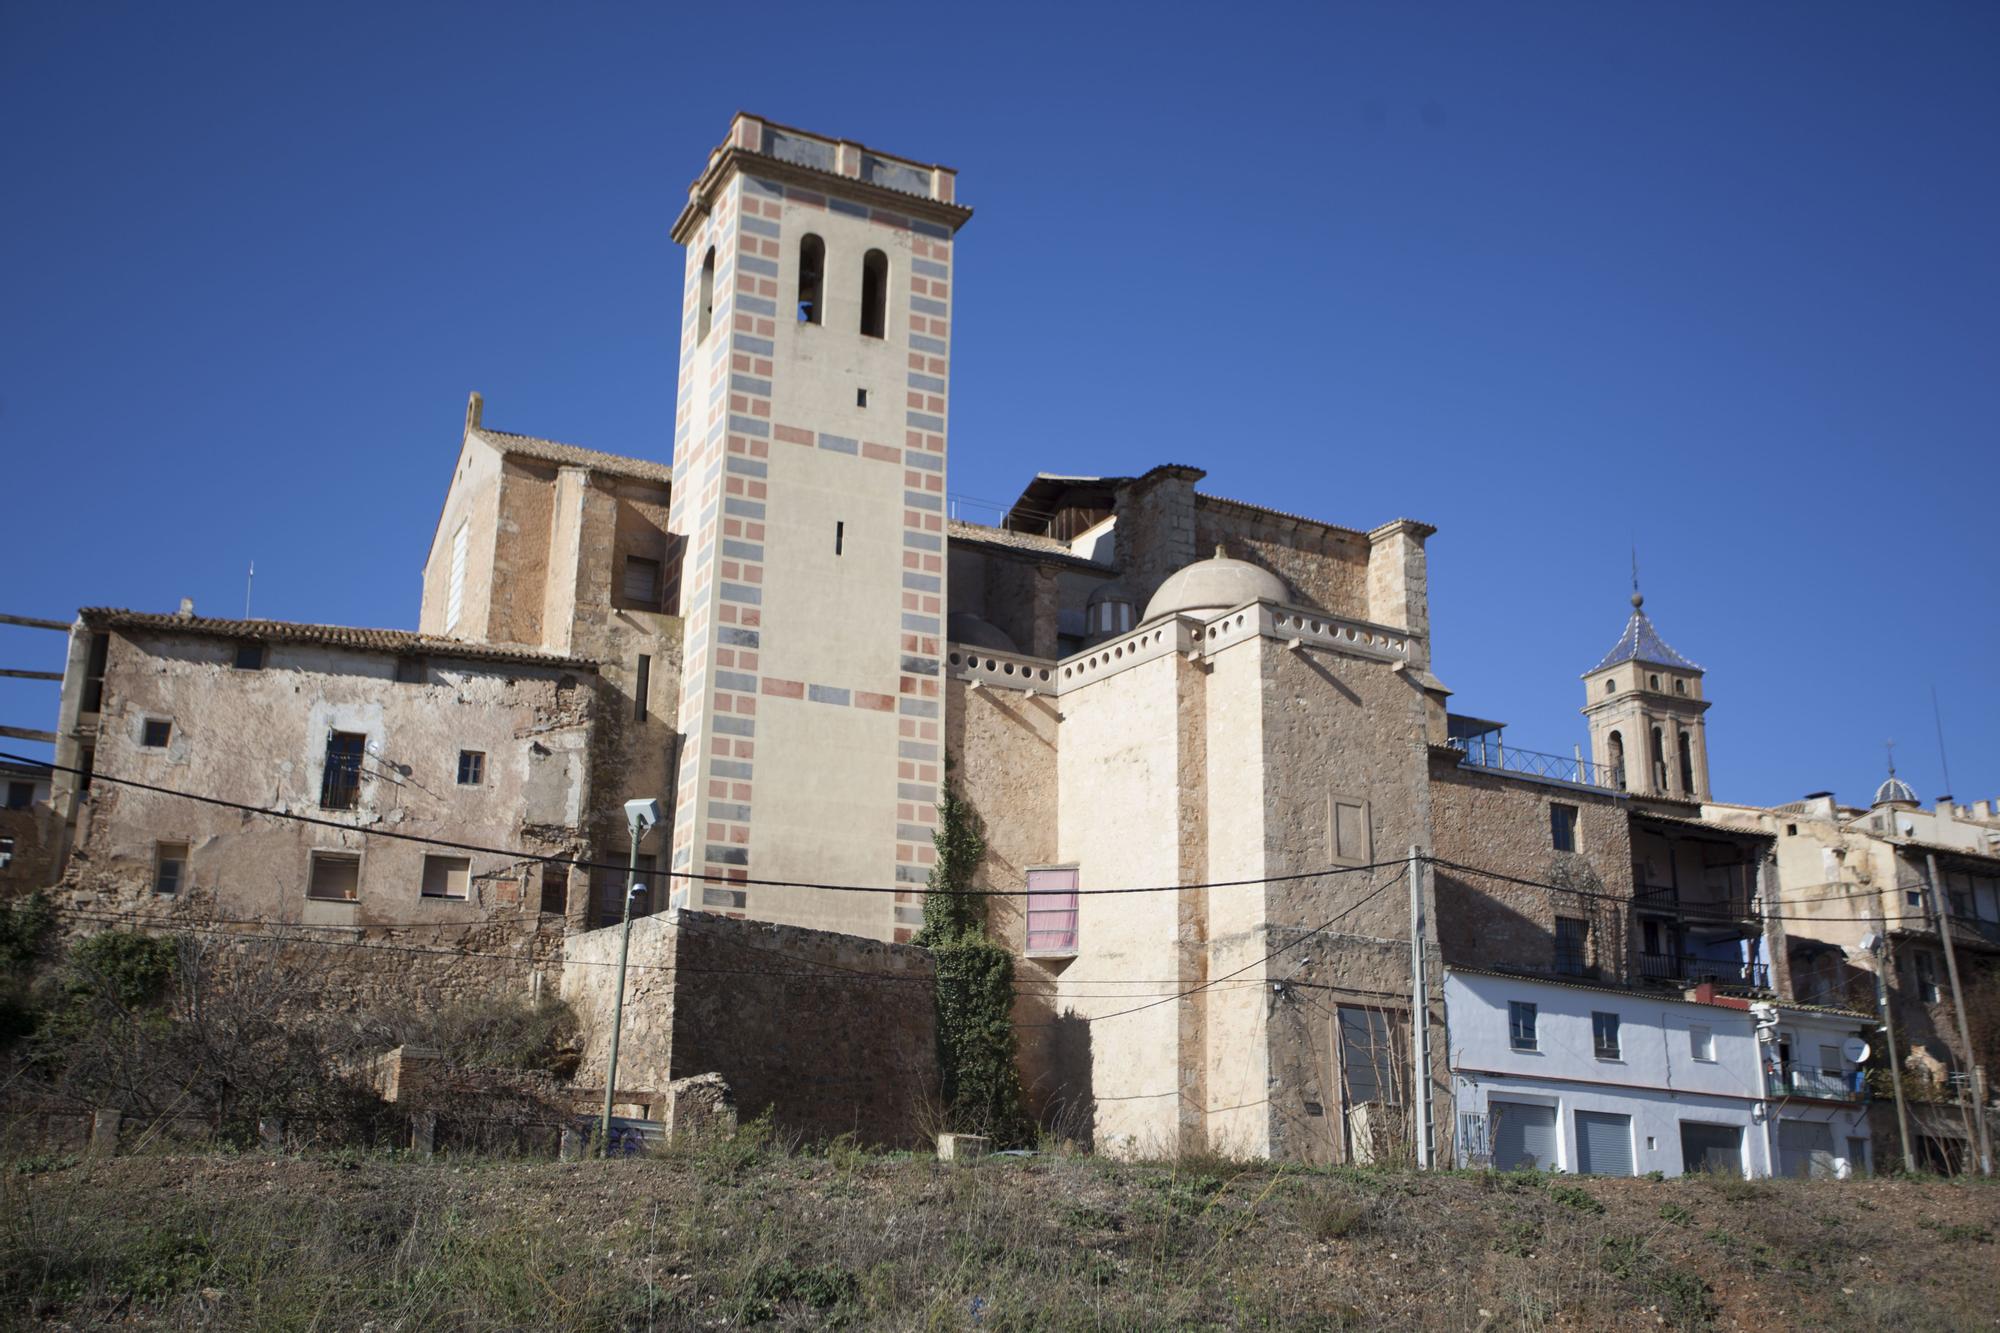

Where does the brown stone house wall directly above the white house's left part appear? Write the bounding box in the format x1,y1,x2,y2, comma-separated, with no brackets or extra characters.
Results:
1430,747,1634,981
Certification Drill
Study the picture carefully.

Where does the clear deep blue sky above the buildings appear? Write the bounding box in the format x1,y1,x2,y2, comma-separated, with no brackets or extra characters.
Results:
0,2,2000,803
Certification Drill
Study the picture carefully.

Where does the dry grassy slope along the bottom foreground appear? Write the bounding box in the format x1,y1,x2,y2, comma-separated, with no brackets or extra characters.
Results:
0,1133,2000,1329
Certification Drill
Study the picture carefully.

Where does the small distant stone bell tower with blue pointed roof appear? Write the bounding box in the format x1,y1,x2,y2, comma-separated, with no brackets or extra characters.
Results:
1584,576,1708,801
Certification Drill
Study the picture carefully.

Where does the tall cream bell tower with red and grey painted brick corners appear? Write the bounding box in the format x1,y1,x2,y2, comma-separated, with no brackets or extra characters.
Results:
668,114,972,939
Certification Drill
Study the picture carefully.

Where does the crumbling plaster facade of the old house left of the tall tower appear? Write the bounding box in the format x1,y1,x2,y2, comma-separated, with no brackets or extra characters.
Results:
62,632,594,993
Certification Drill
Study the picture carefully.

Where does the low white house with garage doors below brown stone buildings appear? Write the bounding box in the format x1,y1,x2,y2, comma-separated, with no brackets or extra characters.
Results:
1444,969,1868,1175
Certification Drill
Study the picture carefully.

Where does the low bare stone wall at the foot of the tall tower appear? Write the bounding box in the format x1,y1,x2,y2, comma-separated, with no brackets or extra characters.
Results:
564,911,938,1145
